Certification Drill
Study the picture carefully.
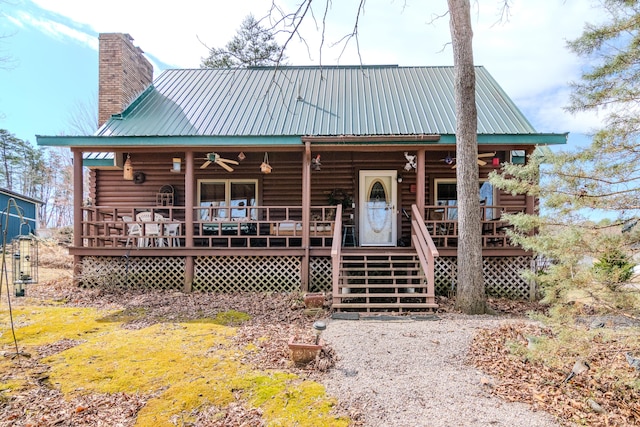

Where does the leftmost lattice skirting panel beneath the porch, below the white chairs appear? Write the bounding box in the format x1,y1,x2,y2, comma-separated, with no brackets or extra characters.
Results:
78,257,185,290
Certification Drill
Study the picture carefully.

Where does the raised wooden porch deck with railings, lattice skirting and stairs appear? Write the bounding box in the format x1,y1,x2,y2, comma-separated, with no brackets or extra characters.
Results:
70,205,530,312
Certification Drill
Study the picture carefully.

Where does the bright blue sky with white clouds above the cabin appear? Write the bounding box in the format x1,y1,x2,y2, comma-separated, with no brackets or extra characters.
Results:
0,0,600,149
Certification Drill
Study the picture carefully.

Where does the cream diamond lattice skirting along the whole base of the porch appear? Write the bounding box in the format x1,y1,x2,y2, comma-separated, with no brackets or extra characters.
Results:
77,256,536,299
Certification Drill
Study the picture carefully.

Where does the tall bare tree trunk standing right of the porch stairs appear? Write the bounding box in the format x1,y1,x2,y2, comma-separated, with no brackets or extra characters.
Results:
448,0,486,314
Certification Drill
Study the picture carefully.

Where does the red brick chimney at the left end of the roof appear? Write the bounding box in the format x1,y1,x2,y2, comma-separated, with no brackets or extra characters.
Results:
98,33,153,127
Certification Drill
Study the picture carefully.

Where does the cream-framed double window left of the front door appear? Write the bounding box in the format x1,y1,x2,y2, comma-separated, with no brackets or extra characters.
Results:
198,179,258,220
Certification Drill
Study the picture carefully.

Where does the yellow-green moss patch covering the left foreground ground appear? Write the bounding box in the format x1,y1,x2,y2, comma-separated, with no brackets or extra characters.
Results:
0,307,349,427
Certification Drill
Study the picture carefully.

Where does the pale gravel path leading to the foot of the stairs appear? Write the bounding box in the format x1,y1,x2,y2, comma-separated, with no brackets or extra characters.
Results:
322,314,559,427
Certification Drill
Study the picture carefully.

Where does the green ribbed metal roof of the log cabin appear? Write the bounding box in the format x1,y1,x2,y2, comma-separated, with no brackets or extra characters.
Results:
94,65,544,137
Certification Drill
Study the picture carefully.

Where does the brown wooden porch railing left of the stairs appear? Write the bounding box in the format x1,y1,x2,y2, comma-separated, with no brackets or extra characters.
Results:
82,206,339,248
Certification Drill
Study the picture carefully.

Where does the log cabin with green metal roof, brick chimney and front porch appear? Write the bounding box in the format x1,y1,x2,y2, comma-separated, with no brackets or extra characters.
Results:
37,34,567,310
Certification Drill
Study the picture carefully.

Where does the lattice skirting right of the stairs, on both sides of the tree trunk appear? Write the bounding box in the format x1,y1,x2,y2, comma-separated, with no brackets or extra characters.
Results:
435,256,535,299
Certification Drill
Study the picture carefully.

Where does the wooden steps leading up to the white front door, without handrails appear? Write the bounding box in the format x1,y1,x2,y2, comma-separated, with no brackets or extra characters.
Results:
332,247,438,312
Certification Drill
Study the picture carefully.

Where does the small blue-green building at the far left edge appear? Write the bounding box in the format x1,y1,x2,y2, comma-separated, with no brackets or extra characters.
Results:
0,188,44,244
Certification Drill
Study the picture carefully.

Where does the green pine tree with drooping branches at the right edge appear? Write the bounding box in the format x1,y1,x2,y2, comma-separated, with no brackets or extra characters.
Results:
491,0,640,312
